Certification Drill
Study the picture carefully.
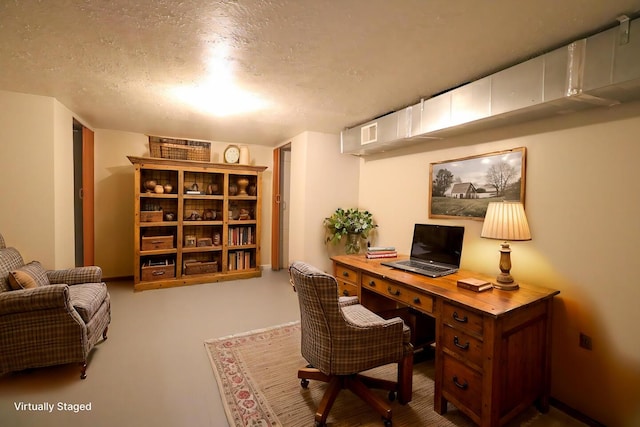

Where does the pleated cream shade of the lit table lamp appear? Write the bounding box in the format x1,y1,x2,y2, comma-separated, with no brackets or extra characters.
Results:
480,202,531,241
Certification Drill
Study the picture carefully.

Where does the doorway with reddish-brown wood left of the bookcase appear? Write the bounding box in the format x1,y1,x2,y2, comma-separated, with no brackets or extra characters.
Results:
73,119,95,267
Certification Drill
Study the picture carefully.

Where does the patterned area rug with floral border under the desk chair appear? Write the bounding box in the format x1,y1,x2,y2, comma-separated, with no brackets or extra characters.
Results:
205,322,538,427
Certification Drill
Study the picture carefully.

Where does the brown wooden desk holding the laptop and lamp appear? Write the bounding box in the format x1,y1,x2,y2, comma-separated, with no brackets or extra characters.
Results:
331,255,559,427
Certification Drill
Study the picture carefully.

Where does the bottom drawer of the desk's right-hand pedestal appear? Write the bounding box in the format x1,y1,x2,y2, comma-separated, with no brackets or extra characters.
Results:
442,355,482,417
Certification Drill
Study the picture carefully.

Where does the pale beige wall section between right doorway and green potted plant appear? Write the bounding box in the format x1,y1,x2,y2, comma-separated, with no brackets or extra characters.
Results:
289,132,359,271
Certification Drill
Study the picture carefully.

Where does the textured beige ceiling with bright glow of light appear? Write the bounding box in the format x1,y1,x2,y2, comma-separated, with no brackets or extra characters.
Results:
0,0,640,145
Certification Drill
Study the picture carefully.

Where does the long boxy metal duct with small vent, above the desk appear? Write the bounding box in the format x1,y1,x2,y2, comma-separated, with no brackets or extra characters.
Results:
341,16,640,155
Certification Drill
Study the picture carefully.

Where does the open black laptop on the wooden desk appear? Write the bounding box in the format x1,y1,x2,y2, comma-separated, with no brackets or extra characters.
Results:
382,224,464,277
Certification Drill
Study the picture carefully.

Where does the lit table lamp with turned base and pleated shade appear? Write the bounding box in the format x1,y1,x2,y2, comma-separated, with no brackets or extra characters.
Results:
480,202,531,291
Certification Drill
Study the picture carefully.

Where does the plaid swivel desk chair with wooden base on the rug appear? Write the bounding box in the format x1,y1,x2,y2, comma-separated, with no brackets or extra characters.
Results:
289,262,413,426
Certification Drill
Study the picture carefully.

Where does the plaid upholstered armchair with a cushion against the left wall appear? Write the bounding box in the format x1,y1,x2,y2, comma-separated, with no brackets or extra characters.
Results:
0,235,111,379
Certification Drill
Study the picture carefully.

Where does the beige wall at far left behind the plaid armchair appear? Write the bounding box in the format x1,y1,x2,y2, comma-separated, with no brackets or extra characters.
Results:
0,91,74,268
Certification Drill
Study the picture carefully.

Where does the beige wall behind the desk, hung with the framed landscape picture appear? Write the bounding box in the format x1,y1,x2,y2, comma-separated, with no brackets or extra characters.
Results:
360,103,640,426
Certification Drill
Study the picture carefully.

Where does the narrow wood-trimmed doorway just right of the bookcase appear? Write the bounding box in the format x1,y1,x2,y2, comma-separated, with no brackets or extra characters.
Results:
271,143,291,271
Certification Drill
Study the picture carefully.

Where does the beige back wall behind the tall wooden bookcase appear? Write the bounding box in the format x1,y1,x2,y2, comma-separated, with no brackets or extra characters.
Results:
95,129,273,277
